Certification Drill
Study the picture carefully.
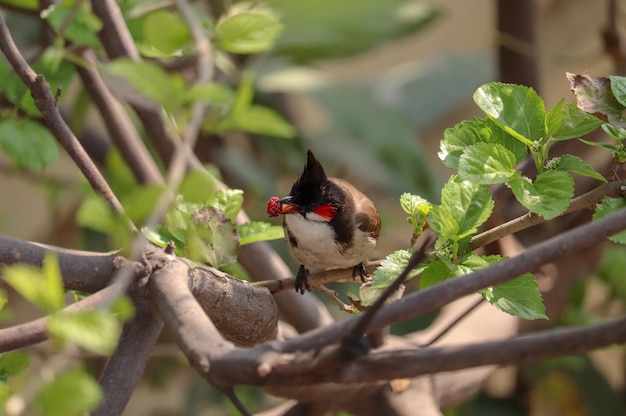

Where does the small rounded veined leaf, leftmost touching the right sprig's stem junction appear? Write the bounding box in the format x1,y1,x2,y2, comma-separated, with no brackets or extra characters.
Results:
459,143,516,185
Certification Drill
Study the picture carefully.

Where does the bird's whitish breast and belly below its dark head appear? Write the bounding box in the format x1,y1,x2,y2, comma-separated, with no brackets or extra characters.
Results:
285,214,376,273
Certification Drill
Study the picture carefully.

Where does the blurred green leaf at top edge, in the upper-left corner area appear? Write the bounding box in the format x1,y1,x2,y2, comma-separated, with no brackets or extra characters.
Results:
41,2,102,49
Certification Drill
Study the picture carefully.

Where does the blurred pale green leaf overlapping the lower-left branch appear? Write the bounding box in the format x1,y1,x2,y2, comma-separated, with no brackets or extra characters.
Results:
48,309,120,355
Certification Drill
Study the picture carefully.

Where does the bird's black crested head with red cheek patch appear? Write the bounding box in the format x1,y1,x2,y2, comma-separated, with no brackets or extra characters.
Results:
279,150,338,221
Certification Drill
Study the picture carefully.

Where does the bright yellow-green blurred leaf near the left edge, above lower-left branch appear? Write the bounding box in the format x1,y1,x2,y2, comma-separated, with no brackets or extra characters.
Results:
2,253,65,313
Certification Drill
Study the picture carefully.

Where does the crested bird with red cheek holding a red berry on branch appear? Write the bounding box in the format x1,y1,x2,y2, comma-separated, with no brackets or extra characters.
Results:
267,150,381,294
